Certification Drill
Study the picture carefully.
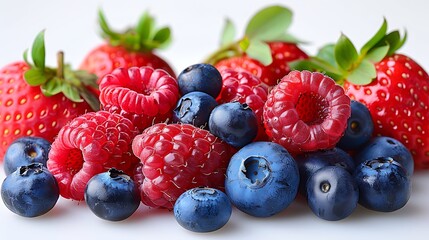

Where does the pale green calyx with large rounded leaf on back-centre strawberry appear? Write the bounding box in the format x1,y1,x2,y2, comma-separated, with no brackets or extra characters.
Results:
204,5,300,66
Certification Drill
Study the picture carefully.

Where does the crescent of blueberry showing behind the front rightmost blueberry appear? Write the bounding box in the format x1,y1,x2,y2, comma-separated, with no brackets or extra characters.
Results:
354,136,414,176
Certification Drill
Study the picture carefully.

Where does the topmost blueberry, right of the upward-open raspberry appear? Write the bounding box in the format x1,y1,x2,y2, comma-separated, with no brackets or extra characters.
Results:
177,63,222,98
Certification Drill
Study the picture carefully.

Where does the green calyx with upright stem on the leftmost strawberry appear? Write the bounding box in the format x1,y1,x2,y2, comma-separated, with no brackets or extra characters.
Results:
24,31,100,111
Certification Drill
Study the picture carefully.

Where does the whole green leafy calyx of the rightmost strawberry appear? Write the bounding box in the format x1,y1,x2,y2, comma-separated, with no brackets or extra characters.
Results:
289,19,407,85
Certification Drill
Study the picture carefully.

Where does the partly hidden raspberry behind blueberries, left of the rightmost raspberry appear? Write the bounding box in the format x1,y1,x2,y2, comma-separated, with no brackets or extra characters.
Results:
216,69,268,141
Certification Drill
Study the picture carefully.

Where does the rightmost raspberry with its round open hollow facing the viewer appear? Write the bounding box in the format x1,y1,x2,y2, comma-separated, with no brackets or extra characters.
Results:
264,71,351,154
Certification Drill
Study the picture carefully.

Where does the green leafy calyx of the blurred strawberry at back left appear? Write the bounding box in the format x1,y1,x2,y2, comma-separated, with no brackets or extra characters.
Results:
98,9,171,52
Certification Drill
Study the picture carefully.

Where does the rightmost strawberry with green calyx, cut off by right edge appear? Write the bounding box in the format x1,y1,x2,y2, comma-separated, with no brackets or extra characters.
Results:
293,21,429,170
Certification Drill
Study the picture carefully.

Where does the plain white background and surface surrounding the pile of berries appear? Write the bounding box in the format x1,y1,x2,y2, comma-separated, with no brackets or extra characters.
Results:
0,0,429,240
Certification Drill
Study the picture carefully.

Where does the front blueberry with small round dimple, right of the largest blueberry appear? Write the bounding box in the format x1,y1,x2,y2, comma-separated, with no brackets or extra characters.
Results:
307,166,359,221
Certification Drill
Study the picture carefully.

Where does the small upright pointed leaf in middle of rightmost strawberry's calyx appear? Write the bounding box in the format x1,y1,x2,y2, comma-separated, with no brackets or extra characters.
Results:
334,34,359,71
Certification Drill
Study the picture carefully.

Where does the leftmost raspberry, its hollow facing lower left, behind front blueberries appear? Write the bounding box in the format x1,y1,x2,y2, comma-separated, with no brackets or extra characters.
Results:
47,111,139,200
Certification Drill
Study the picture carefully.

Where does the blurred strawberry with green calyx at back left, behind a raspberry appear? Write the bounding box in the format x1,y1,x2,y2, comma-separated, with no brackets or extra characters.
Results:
80,10,175,82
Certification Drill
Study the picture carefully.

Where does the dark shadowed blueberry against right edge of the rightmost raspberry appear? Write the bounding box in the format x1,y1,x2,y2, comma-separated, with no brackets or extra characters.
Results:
337,100,374,150
